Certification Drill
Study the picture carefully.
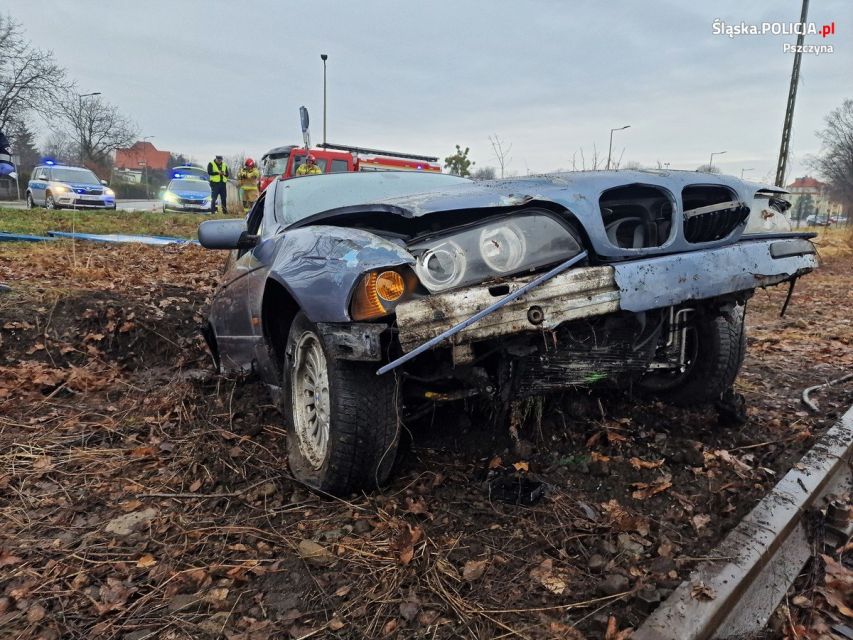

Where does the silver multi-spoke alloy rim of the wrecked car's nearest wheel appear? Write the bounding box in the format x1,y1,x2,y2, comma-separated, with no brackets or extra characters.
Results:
291,332,330,470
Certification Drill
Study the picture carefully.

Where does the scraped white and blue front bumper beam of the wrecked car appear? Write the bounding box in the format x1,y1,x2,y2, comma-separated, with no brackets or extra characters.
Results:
396,238,817,352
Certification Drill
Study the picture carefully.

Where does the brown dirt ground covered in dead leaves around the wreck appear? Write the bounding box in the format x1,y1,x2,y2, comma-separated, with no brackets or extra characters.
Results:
0,242,853,640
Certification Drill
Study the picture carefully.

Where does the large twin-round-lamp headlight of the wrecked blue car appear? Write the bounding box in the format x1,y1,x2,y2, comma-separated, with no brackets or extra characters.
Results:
409,211,581,293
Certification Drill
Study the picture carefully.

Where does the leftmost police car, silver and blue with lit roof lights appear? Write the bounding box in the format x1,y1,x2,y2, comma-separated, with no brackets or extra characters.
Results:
26,163,116,209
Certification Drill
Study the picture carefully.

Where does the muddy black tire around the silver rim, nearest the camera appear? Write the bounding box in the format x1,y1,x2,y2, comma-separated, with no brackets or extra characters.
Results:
282,312,399,496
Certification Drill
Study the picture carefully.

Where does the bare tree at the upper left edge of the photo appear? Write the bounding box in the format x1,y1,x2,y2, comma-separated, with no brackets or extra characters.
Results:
0,14,71,129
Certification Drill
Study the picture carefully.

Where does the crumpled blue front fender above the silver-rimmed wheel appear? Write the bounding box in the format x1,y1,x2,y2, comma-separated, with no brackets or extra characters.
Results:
269,225,415,323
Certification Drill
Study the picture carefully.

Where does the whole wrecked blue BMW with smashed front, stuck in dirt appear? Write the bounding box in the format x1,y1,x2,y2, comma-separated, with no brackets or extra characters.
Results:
199,171,817,494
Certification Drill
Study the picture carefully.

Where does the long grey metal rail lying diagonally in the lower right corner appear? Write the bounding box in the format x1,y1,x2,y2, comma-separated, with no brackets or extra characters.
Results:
632,407,853,640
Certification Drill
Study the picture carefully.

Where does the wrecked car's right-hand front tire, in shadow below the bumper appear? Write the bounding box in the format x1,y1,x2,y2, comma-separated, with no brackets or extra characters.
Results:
639,305,746,406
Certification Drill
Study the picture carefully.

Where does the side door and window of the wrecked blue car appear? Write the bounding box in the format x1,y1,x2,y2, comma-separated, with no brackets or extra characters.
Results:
210,185,280,371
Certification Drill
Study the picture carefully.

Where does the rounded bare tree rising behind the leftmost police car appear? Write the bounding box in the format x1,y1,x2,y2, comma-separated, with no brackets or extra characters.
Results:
52,91,138,166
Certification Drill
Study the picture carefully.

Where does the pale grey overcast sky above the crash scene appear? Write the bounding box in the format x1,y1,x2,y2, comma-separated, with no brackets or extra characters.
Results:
6,0,853,181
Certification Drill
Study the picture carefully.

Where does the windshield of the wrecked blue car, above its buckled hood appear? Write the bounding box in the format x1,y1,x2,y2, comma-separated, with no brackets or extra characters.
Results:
275,171,470,225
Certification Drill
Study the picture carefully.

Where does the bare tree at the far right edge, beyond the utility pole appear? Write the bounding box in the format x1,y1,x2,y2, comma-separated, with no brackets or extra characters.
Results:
809,98,853,207
